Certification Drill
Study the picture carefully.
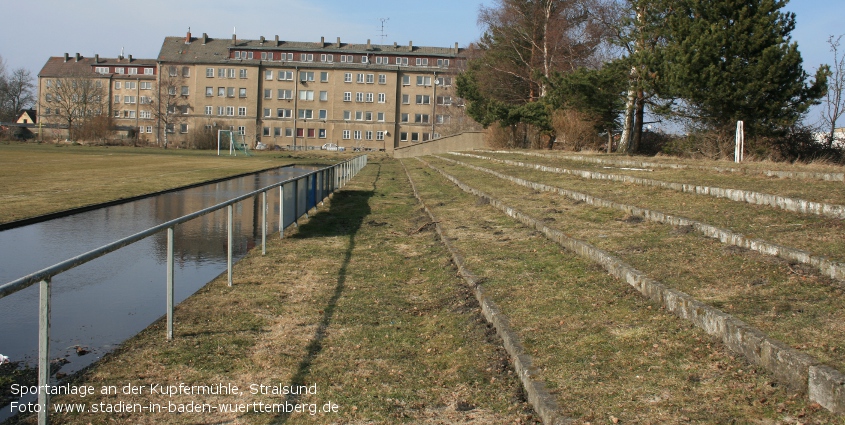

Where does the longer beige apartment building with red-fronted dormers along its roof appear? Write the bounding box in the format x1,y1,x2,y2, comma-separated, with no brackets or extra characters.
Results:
158,32,464,151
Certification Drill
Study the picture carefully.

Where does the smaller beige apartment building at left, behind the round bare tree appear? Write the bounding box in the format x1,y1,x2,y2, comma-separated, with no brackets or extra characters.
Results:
38,53,159,141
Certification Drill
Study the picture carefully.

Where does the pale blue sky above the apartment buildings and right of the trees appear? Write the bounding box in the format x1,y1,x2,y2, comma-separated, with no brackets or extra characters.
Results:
0,0,845,124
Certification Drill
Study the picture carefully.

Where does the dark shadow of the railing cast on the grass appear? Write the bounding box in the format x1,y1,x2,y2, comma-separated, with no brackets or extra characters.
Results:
274,164,381,424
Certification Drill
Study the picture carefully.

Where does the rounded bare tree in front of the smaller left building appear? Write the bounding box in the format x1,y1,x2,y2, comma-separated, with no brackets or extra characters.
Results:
43,75,108,140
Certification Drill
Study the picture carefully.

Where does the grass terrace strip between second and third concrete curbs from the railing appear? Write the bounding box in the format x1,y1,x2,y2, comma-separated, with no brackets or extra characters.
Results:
426,155,845,370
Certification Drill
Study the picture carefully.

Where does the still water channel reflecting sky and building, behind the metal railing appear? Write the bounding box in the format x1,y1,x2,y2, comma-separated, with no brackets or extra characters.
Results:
0,167,316,396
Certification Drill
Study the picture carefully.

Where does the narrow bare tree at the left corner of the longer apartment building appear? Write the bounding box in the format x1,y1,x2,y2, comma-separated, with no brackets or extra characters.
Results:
153,66,191,149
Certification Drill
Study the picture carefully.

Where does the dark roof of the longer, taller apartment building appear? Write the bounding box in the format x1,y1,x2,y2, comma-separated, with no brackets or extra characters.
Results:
158,34,464,65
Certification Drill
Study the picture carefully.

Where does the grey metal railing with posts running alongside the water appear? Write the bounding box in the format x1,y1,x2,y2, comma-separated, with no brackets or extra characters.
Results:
0,155,367,425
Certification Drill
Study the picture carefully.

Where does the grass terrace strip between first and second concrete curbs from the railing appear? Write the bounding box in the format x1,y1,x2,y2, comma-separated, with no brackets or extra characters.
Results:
406,158,839,424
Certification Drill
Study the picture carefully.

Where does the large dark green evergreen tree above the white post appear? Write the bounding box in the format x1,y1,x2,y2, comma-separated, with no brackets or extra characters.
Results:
651,0,828,136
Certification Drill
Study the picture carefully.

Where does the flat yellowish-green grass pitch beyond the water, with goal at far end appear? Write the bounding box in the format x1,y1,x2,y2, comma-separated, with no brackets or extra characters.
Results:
0,144,348,224
